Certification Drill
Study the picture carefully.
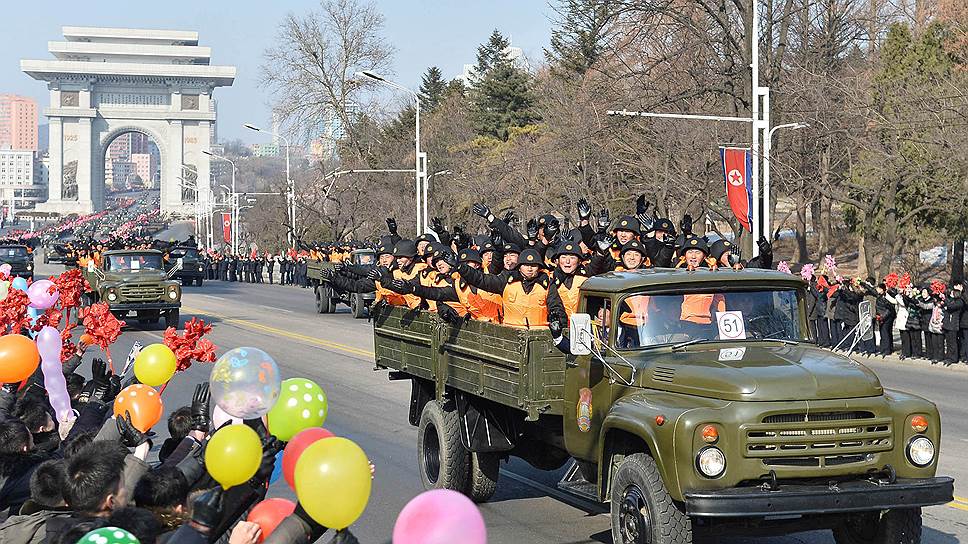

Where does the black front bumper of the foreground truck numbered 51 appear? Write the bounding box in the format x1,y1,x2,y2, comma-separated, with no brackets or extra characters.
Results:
685,476,954,518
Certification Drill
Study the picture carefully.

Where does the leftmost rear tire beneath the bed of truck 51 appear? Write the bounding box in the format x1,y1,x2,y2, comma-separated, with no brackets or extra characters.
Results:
417,400,470,493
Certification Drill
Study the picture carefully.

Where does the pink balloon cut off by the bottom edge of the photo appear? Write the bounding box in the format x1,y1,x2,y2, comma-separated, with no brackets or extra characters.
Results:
393,489,487,544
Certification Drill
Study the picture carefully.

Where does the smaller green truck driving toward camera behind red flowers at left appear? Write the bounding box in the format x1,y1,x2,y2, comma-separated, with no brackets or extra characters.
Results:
84,249,181,328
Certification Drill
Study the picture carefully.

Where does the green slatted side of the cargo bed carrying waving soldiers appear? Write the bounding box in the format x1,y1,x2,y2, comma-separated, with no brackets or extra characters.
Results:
373,306,565,421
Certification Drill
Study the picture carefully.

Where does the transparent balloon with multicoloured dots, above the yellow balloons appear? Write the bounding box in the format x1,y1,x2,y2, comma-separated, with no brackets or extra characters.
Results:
209,348,280,419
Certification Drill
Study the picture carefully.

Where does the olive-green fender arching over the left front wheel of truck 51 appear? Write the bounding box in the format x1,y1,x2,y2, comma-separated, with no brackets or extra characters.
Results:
598,394,682,500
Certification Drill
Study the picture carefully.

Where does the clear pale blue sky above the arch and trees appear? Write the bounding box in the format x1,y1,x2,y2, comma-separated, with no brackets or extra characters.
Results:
0,0,552,142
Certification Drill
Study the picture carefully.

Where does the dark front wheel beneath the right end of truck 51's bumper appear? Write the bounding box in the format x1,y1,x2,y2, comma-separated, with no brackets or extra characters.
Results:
834,508,921,544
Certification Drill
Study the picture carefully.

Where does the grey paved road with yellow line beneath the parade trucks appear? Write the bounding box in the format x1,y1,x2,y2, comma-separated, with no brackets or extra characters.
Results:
38,266,968,544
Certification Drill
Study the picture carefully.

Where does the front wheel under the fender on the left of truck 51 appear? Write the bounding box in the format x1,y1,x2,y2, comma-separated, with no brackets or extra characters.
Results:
611,453,692,544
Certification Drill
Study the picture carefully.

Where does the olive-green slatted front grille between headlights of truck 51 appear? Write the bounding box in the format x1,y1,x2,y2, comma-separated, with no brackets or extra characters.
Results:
744,412,893,467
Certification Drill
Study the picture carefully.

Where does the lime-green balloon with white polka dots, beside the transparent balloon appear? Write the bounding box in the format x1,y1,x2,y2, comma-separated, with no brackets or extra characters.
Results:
269,378,329,442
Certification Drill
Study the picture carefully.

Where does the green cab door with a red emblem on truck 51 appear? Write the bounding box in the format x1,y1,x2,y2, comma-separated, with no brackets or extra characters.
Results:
564,295,614,461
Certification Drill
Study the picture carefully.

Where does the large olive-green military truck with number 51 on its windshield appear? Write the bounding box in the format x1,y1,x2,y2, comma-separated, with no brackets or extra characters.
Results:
374,269,953,544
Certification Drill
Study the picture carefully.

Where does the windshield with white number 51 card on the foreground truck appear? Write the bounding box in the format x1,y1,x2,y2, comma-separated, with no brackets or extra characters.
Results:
617,289,808,349
